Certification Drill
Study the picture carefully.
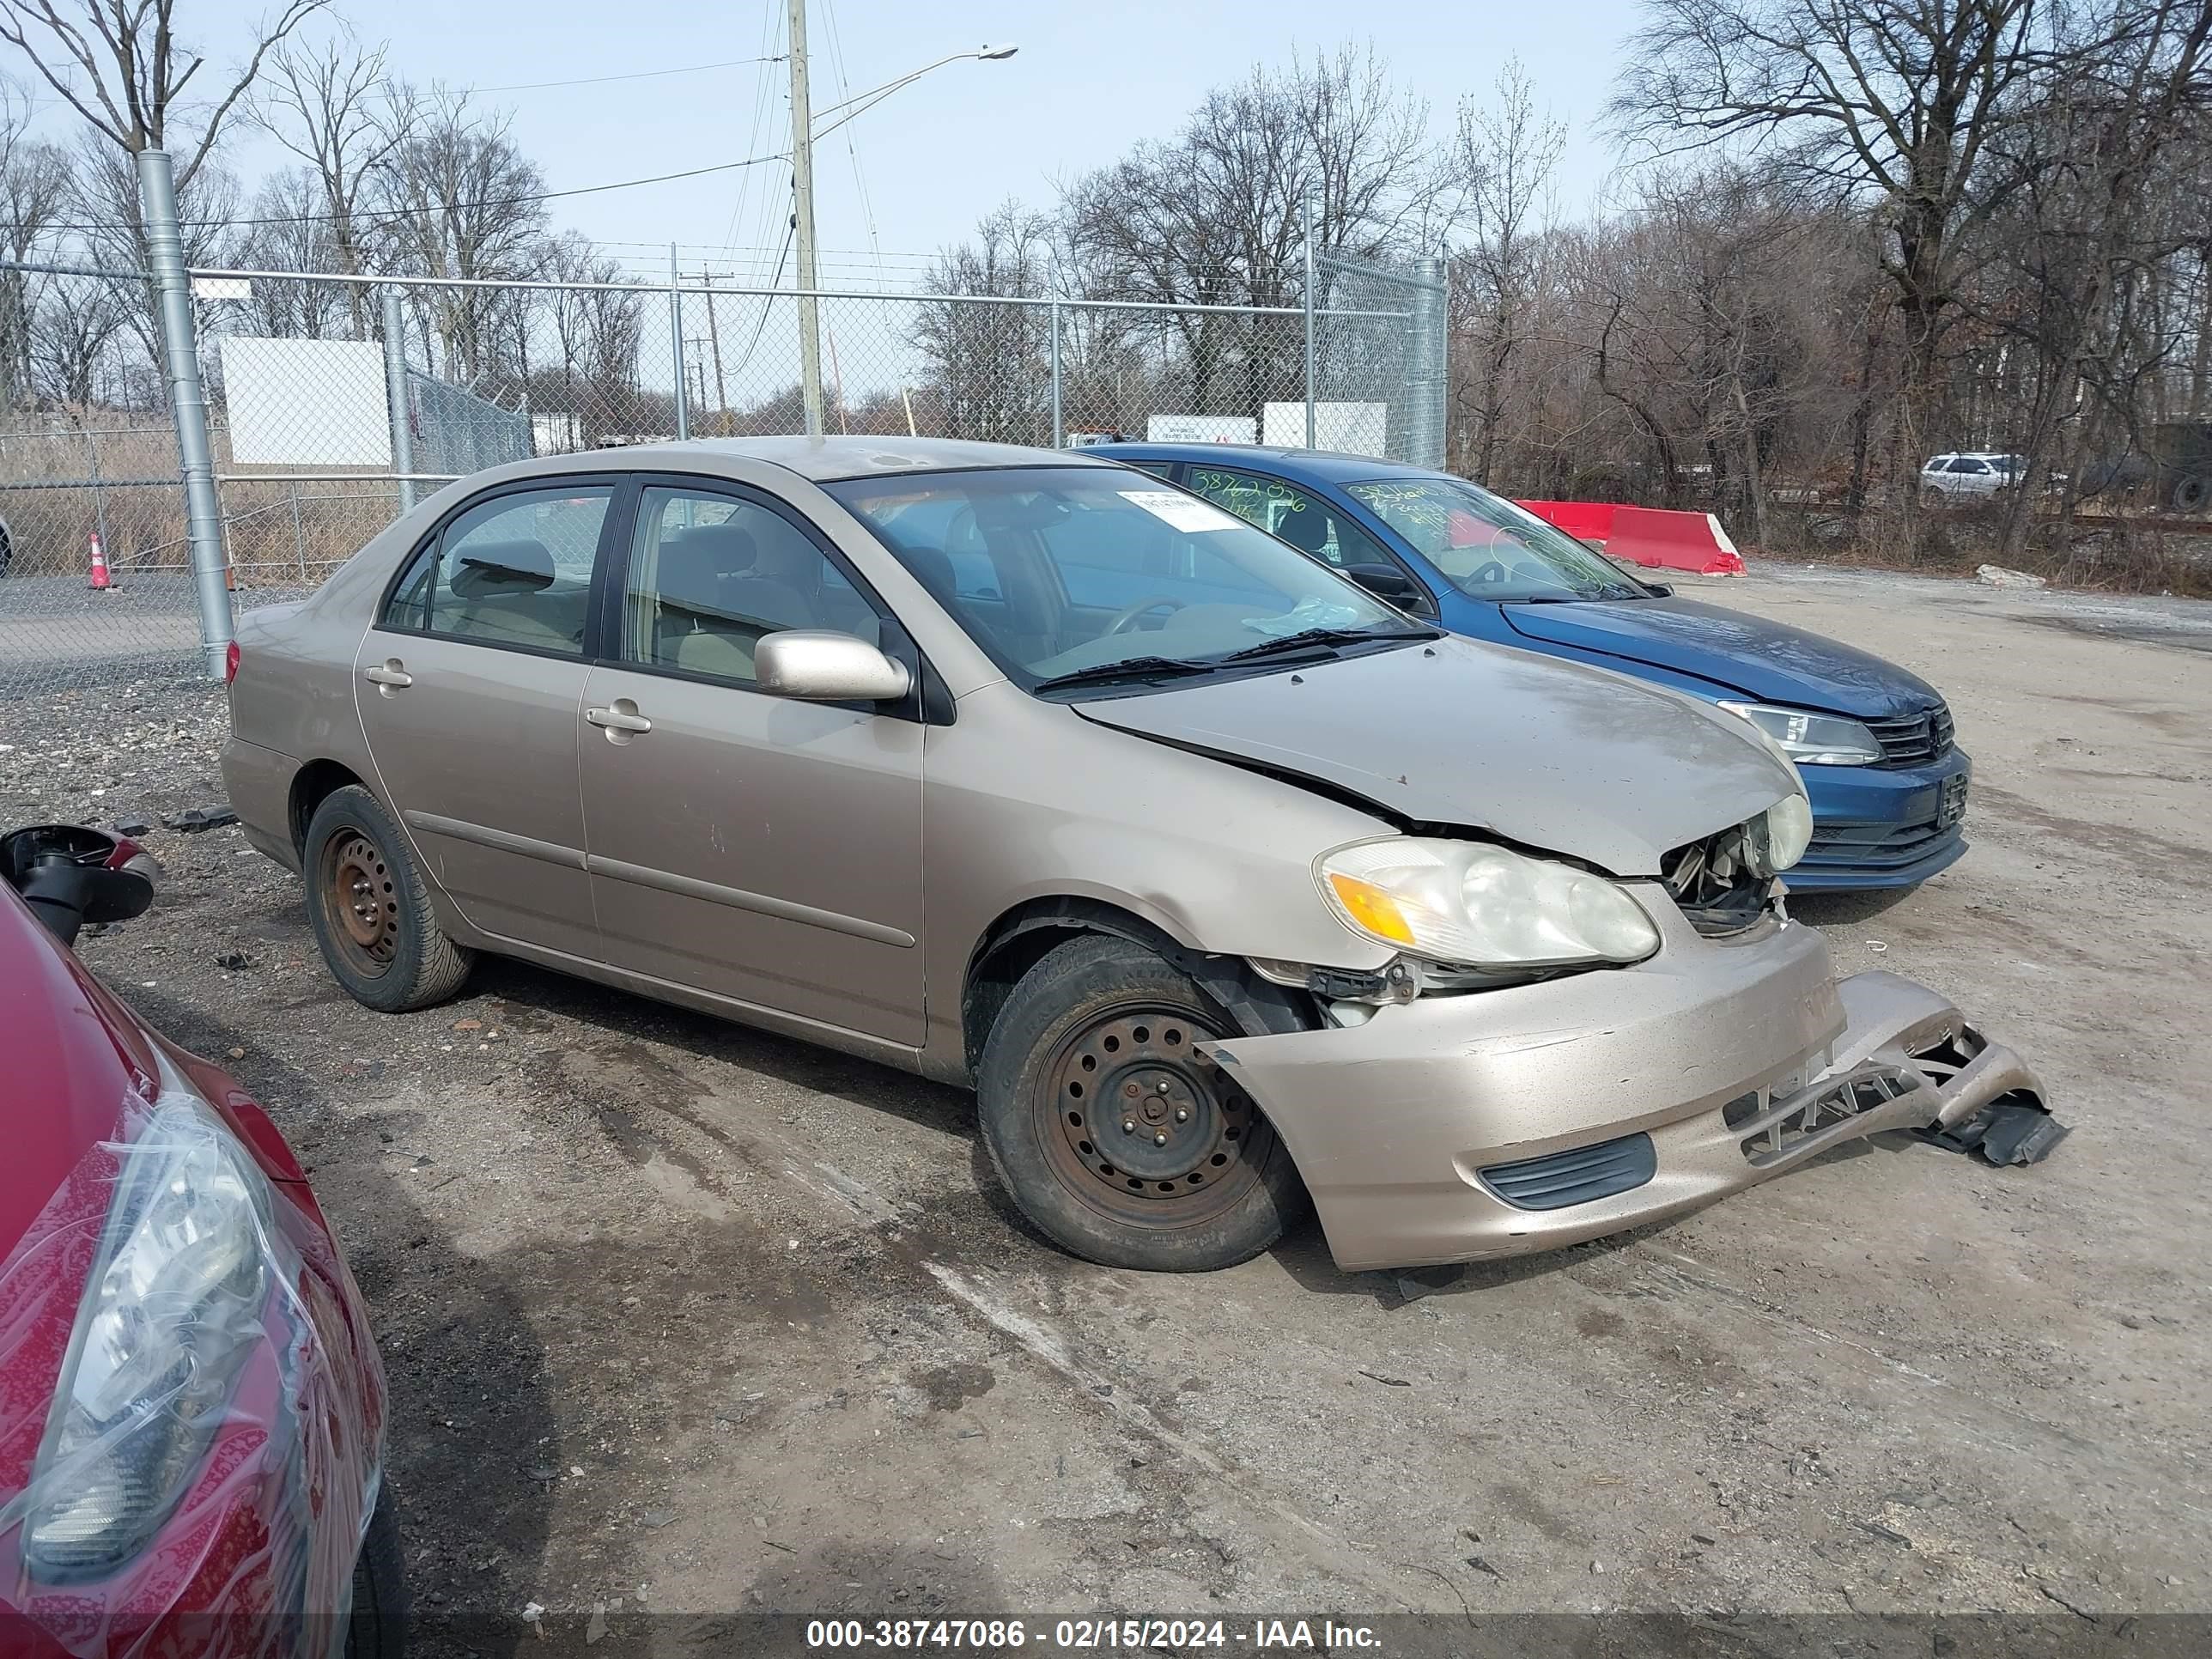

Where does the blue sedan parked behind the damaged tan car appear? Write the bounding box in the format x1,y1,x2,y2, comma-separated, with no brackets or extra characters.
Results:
1086,442,1973,891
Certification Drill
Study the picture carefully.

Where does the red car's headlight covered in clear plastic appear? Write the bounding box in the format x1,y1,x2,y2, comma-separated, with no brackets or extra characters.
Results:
7,1064,283,1583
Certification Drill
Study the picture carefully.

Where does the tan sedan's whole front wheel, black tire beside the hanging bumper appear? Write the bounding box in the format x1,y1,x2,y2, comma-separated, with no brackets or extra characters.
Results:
975,936,1307,1272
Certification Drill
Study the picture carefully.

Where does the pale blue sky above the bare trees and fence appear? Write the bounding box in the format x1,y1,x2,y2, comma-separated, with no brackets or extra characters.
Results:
0,0,1635,288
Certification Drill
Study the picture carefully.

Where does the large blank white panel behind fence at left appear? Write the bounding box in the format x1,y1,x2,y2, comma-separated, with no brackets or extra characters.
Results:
222,334,392,467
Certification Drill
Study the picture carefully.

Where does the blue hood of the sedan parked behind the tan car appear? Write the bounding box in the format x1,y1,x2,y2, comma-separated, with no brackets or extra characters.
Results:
1498,599,1942,719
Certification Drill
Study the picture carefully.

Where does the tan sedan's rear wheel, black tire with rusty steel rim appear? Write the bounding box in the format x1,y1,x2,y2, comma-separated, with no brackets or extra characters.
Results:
301,783,476,1013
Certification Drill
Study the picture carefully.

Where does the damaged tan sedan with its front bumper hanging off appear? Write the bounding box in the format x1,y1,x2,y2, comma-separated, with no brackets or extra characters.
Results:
223,438,2062,1267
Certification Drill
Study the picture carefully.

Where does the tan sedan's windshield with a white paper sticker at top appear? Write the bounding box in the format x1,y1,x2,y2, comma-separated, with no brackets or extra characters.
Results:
825,467,1436,690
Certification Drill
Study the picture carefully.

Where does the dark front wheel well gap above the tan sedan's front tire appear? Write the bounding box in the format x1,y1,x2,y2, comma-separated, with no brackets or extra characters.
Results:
960,896,1314,1078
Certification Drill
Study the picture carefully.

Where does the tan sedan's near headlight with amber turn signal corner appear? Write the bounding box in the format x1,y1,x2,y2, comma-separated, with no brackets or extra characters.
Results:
1316,836,1659,969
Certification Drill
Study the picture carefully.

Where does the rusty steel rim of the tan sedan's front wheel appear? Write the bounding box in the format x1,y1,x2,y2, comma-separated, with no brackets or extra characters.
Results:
1037,1005,1272,1228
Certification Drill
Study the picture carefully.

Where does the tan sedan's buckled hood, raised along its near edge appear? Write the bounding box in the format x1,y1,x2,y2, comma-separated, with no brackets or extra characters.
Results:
1075,637,1798,876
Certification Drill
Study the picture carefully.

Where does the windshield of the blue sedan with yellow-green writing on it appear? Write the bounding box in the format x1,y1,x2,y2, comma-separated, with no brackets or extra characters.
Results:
1345,477,1646,599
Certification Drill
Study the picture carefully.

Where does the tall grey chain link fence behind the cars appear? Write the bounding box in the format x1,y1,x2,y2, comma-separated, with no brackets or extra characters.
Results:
0,258,1444,703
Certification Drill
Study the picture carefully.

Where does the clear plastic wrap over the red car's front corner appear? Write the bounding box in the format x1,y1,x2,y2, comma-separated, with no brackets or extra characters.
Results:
0,1084,385,1659
